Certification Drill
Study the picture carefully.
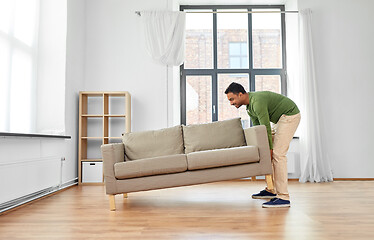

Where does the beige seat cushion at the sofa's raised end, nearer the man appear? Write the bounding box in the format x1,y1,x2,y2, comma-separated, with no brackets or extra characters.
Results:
187,146,260,170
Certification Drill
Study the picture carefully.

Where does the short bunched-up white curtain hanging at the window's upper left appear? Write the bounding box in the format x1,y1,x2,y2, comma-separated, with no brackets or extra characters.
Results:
141,11,186,66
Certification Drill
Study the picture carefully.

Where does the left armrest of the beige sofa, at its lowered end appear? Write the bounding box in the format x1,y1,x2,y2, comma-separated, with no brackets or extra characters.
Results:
101,143,125,194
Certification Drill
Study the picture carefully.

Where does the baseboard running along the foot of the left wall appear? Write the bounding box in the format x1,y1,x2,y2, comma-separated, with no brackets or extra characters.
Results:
0,178,78,215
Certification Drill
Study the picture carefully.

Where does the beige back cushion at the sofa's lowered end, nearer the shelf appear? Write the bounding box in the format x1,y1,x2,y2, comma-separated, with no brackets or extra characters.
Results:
122,126,184,160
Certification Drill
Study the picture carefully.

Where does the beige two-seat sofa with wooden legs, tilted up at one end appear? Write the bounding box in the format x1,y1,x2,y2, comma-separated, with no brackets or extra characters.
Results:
101,118,273,210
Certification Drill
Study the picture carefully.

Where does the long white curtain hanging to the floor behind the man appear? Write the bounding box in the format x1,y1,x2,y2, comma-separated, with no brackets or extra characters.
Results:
299,9,333,182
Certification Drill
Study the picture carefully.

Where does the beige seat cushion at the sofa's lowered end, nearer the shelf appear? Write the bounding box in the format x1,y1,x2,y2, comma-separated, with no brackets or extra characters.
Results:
114,154,187,179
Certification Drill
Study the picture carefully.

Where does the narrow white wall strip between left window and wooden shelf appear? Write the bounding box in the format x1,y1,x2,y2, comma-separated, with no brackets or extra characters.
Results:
63,0,86,181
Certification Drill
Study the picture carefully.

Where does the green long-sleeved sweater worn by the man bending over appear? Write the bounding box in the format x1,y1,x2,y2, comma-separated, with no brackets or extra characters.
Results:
247,91,300,149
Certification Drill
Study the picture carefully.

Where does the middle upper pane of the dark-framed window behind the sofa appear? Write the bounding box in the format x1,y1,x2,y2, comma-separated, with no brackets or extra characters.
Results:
217,9,248,68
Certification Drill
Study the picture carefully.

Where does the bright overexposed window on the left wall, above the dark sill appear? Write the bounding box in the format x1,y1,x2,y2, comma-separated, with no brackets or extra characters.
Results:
0,0,38,133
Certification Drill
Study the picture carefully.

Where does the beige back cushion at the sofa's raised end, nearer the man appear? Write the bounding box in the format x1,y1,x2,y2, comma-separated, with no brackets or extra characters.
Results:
183,118,246,154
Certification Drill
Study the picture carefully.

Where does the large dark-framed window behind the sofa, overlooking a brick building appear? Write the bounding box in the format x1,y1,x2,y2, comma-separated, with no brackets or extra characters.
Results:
180,5,286,127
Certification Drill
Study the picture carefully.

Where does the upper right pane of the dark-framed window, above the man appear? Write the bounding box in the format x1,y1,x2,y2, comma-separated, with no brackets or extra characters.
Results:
252,8,282,68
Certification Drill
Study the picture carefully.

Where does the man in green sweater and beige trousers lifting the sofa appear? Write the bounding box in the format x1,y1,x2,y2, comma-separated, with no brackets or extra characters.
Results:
225,82,300,207
